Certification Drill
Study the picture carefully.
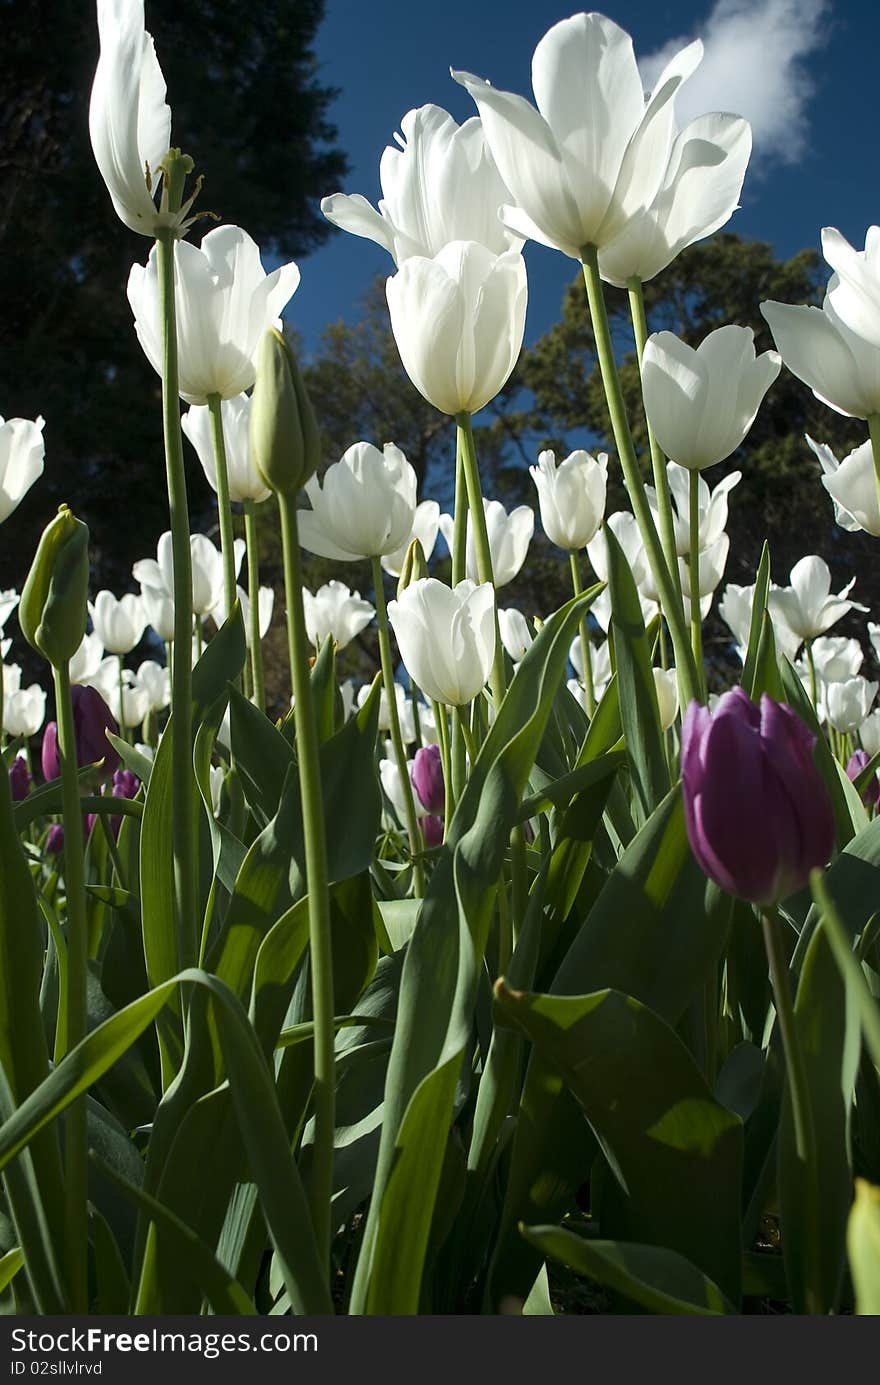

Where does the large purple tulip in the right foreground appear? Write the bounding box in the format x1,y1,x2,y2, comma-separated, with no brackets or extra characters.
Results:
682,688,834,904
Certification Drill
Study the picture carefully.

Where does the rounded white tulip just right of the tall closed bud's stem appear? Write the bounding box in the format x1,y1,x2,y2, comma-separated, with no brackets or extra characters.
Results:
297,442,417,562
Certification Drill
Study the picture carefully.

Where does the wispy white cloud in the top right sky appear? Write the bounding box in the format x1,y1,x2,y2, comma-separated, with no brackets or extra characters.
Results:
639,0,830,163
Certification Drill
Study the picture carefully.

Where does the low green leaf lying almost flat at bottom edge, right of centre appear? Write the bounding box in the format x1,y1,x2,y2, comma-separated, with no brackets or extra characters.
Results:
522,1226,733,1317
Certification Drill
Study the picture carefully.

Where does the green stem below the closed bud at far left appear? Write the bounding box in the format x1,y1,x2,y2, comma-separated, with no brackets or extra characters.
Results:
53,663,89,1313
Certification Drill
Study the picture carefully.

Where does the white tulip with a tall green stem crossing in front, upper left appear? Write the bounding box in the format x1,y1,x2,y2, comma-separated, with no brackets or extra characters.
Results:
127,226,299,404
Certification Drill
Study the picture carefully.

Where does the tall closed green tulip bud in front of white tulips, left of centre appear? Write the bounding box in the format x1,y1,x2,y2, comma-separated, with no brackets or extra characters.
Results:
249,327,320,494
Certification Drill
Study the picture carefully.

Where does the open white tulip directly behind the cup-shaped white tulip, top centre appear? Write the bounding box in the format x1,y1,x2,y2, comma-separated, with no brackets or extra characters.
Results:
322,105,520,265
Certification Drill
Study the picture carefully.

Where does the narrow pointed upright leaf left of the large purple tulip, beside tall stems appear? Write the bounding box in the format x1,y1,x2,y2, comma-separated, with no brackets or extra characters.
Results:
603,525,669,821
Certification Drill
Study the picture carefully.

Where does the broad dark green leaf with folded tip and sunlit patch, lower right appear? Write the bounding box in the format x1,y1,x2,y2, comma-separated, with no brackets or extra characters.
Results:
495,981,743,1303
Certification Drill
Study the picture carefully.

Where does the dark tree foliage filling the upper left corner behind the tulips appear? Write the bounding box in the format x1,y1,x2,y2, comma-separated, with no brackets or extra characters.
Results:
0,0,346,591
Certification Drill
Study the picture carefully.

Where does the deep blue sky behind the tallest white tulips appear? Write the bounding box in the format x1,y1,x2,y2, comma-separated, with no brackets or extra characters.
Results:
288,0,880,349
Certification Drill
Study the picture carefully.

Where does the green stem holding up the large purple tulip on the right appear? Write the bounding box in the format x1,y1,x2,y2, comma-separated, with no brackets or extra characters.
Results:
761,904,823,1313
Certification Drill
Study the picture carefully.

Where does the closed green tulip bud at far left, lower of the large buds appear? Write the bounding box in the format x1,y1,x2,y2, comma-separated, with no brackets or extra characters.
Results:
18,506,89,669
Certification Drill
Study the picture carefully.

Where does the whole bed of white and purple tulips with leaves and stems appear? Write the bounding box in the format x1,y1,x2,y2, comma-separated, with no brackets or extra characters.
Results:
0,0,880,1316
